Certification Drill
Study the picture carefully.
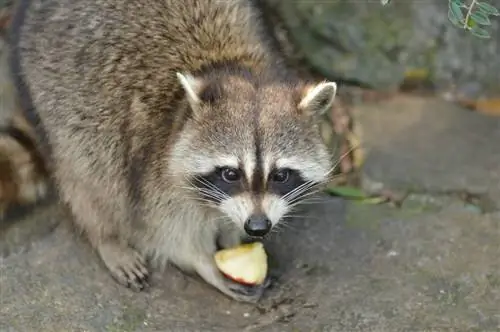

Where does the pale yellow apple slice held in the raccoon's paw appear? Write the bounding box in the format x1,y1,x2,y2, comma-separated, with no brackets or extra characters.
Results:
214,242,267,285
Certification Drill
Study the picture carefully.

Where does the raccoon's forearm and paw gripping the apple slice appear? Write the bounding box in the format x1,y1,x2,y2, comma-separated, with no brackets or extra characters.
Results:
196,258,271,303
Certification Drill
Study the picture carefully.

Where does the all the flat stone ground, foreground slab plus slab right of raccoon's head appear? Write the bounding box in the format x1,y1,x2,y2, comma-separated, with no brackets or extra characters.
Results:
0,96,500,332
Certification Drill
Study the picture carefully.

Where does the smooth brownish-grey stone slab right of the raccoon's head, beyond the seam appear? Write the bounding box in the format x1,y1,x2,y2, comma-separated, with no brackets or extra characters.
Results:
355,95,500,206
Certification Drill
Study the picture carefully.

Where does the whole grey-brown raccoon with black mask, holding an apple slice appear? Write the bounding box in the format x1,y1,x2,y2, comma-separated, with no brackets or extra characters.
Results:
7,0,337,302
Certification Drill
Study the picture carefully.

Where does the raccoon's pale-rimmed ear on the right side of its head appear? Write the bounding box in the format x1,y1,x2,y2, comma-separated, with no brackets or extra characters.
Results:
298,82,337,116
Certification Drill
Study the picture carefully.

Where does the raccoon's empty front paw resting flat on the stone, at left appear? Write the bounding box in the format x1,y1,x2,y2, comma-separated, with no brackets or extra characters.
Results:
98,242,149,291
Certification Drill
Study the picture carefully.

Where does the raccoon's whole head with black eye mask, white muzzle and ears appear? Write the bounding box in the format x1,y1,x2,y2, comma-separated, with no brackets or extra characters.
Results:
171,70,336,237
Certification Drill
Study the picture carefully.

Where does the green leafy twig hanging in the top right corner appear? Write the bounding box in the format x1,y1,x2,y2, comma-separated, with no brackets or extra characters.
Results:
380,0,500,38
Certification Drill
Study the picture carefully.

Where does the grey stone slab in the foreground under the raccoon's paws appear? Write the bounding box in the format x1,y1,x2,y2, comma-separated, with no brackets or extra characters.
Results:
0,198,500,331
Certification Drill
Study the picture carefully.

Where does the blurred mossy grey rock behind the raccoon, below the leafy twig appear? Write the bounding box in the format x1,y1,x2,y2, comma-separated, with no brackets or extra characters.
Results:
264,0,500,95
